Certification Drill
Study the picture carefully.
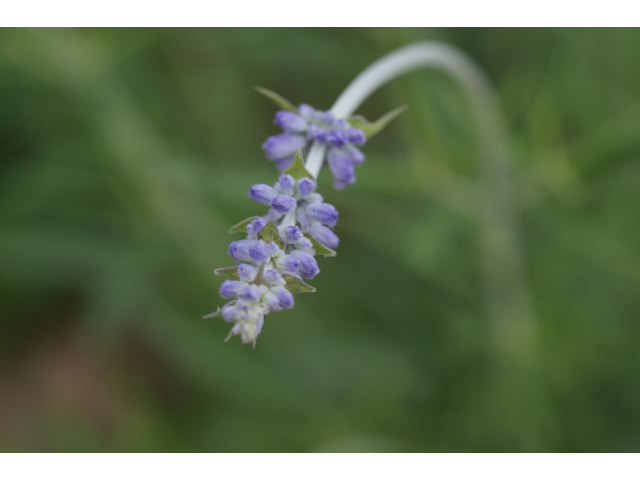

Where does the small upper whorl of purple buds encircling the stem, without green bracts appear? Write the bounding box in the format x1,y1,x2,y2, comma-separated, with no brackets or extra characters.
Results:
262,104,366,189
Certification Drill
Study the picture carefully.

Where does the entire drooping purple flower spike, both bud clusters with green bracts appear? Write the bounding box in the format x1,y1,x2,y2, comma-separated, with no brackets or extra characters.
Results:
204,88,403,348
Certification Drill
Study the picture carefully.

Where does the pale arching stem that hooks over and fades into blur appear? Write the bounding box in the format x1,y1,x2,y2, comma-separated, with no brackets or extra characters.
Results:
305,42,545,447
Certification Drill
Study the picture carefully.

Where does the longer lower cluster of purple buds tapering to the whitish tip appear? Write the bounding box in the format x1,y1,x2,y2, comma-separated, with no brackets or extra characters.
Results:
207,159,339,347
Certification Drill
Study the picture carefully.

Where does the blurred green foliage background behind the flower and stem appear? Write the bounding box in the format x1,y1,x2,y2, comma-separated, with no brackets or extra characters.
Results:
0,29,640,452
